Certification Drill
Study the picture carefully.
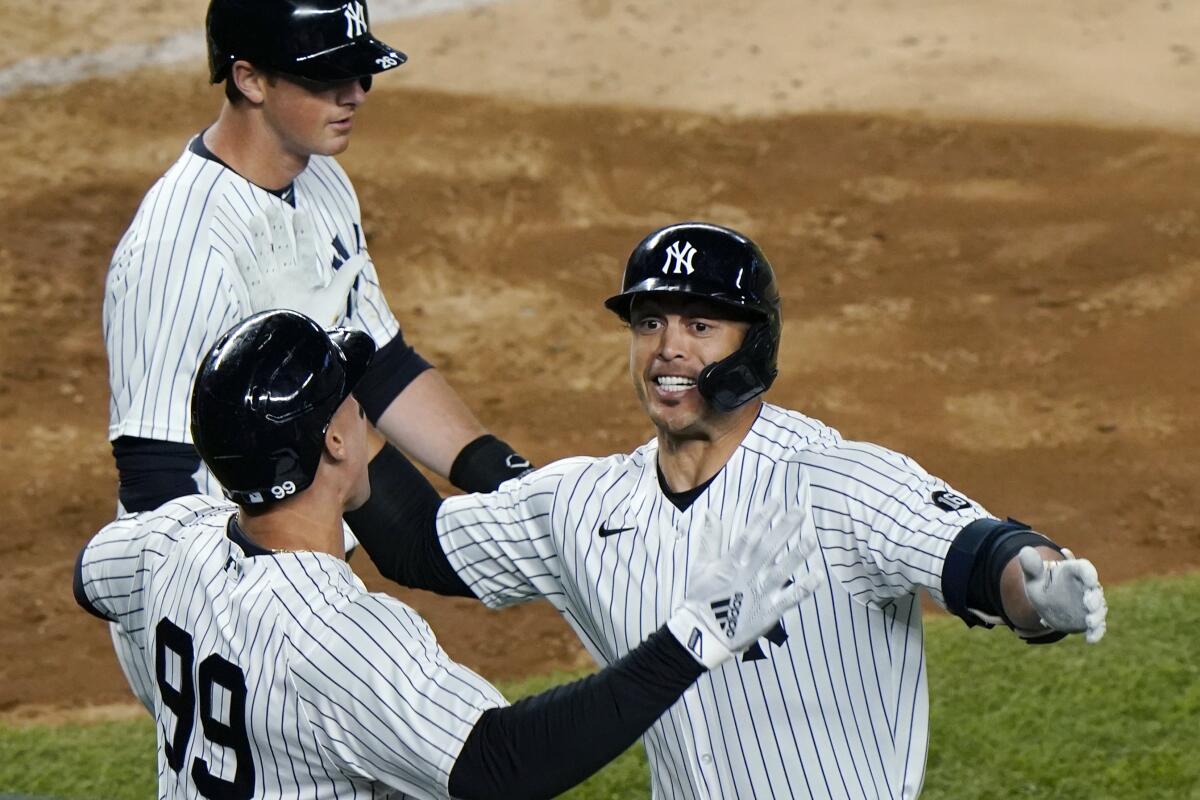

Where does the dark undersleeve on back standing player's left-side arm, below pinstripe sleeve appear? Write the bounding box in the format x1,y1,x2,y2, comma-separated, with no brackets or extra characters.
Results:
113,437,200,512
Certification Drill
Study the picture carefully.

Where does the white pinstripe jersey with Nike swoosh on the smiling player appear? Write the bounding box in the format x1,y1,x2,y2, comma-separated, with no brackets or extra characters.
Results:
438,405,989,800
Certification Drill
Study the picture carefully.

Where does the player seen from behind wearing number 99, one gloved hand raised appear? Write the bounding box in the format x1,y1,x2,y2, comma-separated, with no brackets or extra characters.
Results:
74,311,820,800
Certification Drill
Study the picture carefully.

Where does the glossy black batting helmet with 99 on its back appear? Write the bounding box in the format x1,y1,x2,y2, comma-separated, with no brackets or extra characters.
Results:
192,311,376,505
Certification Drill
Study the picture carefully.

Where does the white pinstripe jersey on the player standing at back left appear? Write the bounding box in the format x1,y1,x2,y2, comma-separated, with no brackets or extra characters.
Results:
103,138,400,497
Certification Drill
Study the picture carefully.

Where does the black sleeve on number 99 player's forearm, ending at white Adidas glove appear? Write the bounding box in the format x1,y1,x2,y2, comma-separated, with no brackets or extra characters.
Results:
450,627,704,800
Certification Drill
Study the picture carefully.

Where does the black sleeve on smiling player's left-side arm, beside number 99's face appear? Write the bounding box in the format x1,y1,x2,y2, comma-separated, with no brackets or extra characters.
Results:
344,444,475,597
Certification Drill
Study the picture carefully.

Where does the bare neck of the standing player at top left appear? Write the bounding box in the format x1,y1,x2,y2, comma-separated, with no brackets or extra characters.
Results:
204,101,308,192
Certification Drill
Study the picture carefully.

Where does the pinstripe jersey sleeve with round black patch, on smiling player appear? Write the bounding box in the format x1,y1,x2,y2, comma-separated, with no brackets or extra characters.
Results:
792,441,991,607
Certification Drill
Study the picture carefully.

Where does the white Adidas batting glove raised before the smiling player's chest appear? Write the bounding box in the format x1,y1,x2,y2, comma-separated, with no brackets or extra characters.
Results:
667,507,822,669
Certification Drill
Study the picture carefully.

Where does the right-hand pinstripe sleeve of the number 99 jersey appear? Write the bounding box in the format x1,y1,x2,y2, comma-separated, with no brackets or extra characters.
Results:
289,595,508,798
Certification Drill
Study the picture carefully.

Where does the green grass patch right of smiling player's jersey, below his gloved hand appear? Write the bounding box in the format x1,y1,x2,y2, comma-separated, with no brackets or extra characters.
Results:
923,575,1200,800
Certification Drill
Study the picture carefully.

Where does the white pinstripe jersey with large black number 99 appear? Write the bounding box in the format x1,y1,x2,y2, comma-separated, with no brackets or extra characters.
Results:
83,495,505,800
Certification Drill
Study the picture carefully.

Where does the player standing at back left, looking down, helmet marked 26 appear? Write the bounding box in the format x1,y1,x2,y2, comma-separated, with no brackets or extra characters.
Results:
103,0,529,703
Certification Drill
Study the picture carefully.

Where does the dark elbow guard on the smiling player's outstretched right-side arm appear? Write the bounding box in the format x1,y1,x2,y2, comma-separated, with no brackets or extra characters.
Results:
942,518,1067,644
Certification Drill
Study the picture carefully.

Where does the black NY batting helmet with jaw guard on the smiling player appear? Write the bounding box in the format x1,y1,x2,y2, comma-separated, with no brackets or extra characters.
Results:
605,222,781,411
